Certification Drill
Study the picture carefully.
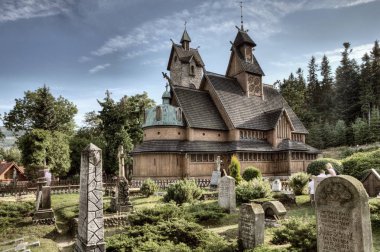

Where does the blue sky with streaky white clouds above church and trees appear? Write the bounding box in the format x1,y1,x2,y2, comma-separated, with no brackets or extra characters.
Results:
0,0,380,124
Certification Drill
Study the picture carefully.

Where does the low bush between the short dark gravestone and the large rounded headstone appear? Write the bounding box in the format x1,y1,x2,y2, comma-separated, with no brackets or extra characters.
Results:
271,218,317,252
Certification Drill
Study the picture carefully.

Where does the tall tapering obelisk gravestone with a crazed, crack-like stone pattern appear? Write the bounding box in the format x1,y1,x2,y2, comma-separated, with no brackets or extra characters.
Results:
75,144,106,252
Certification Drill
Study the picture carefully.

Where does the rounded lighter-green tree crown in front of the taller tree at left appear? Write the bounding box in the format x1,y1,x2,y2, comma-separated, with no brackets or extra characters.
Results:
17,129,70,179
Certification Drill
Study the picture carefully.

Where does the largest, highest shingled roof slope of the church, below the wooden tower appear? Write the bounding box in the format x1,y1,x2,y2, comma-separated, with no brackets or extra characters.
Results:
205,72,308,133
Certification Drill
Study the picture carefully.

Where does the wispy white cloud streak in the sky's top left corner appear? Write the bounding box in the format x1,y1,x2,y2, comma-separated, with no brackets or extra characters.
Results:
0,0,74,23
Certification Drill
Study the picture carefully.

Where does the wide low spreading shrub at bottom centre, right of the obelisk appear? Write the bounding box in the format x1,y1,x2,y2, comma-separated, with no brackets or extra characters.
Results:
106,219,233,251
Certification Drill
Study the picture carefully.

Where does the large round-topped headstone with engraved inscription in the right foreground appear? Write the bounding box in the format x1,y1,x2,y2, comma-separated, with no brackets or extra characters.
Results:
315,175,372,252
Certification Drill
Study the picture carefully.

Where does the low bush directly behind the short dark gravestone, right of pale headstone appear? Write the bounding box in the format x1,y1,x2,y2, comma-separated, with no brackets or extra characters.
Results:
236,179,272,203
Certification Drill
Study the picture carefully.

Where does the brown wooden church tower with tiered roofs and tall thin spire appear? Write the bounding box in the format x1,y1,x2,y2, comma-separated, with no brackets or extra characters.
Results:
226,5,264,99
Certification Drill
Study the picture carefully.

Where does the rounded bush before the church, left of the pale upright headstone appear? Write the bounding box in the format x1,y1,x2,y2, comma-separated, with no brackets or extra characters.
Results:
164,179,202,205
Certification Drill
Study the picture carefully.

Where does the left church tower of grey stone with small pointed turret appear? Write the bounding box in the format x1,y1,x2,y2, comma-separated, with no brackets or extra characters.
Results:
167,26,204,89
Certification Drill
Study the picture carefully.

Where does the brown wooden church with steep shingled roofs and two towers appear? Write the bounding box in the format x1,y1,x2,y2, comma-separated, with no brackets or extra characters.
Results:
132,25,319,179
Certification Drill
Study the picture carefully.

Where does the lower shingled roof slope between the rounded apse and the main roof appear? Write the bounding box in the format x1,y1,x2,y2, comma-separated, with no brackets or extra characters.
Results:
172,86,227,130
